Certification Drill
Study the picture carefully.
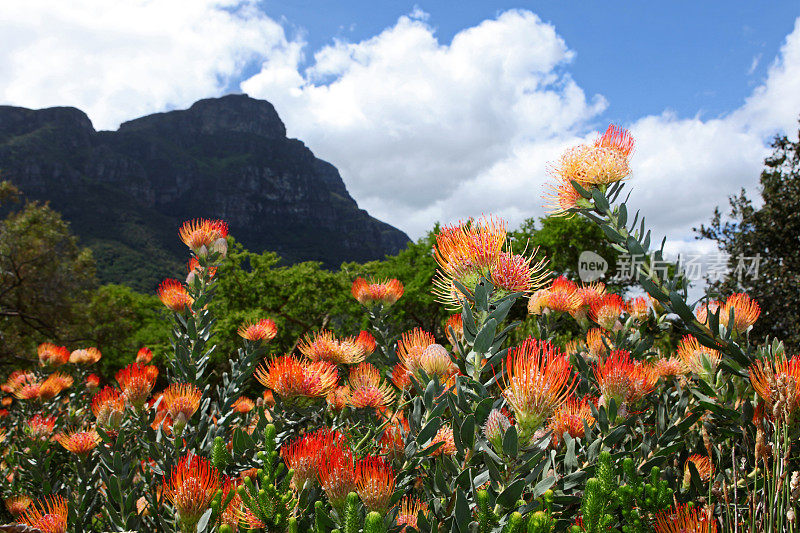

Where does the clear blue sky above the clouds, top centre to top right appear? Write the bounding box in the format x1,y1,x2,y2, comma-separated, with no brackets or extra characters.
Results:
259,0,800,122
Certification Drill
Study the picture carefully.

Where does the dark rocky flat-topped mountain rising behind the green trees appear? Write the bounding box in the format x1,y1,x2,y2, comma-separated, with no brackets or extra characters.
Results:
0,94,408,291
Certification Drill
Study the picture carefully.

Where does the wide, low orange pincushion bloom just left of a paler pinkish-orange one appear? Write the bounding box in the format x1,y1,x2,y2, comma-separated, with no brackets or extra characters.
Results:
255,355,339,402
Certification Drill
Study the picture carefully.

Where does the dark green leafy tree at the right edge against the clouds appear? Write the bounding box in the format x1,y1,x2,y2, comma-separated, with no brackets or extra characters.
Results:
695,129,800,349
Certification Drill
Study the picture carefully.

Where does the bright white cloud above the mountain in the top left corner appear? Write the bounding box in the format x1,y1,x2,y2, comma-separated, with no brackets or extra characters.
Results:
0,0,300,129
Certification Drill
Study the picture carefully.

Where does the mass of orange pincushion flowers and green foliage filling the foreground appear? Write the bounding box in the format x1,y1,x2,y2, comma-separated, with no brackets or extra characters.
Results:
0,126,788,533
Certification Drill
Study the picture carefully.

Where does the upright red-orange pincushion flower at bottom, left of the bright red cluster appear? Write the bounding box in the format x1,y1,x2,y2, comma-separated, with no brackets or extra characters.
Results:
164,454,220,531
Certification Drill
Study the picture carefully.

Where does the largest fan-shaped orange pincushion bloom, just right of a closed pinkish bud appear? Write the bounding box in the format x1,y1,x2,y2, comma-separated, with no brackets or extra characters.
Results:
500,338,576,443
